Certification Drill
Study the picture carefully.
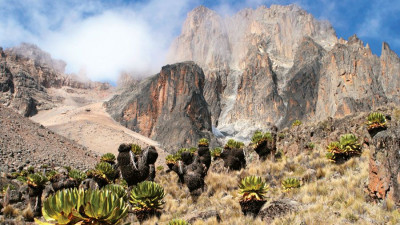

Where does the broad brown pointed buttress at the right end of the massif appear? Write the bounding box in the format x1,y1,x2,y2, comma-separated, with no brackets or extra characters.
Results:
314,36,388,121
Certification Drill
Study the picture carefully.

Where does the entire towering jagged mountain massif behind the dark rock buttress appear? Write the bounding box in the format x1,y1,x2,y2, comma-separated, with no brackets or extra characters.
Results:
168,5,400,140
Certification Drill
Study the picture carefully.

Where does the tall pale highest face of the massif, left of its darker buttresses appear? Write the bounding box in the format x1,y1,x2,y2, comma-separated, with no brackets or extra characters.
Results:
168,5,337,139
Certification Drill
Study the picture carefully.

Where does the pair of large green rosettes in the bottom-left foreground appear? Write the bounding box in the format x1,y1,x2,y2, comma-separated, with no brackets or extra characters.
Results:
35,189,129,224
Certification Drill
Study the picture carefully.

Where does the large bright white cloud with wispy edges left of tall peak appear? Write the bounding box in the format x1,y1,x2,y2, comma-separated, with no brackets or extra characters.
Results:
0,0,196,81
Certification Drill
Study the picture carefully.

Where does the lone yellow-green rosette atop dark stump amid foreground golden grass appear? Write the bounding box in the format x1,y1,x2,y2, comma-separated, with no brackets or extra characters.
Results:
239,176,269,201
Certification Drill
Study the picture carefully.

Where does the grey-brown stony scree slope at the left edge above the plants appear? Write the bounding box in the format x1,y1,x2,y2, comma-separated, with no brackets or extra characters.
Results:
0,106,97,172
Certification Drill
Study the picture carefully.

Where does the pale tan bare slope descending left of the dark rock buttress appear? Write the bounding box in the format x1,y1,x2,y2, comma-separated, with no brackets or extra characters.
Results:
31,88,165,163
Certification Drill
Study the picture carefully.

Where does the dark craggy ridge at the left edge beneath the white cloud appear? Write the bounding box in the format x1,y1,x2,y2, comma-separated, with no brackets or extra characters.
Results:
0,44,110,116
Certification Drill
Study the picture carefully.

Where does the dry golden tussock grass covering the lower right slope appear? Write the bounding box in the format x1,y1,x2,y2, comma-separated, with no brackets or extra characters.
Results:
126,145,400,225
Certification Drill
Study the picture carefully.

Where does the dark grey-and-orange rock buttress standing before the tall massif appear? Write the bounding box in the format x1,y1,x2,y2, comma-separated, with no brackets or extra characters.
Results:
105,62,211,149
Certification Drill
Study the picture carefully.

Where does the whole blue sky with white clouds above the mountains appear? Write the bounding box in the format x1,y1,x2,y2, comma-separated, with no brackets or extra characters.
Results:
0,0,400,83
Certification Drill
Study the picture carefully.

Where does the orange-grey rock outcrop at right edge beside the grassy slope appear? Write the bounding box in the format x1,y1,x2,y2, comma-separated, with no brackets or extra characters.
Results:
368,124,400,205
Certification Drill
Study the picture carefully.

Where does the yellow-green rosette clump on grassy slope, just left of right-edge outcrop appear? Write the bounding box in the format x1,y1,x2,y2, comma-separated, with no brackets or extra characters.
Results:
326,134,361,162
